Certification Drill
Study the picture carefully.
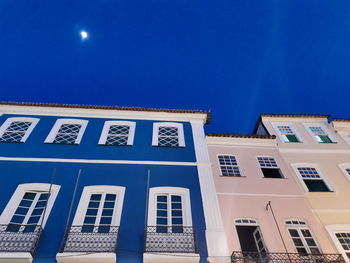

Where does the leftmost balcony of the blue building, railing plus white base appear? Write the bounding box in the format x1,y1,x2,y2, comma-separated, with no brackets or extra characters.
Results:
0,224,42,263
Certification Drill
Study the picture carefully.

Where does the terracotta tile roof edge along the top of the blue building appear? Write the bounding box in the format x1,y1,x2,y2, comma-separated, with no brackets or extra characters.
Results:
0,101,211,124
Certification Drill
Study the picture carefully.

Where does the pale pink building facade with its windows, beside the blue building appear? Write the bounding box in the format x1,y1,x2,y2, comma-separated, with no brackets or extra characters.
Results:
206,134,342,262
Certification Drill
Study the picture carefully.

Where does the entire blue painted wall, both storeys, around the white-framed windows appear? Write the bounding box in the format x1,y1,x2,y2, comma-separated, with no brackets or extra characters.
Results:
0,115,207,263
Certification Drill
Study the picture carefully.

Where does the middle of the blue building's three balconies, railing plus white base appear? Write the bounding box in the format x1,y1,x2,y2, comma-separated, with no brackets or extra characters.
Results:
56,226,119,262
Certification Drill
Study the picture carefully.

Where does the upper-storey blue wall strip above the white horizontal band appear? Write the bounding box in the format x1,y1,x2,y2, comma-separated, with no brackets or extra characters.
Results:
0,115,196,162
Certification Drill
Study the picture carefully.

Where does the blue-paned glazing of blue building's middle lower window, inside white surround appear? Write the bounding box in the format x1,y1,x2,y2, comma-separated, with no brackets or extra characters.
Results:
81,193,117,233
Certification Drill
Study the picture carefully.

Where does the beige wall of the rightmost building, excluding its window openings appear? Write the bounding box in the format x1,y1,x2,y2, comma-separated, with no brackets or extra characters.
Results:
262,117,350,262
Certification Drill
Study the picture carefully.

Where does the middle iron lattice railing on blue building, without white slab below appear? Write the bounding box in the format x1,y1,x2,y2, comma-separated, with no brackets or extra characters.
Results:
60,226,119,253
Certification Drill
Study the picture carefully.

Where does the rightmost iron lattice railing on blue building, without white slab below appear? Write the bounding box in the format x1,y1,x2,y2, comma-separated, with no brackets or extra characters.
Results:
144,226,197,253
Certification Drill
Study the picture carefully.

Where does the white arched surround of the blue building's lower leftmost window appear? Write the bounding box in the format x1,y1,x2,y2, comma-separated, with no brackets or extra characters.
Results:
0,183,61,228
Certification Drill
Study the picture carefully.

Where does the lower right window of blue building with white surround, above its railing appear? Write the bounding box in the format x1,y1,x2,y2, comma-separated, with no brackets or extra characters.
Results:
148,187,192,233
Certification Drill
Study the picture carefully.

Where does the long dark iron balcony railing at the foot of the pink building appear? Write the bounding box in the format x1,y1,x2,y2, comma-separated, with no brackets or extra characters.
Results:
231,251,345,263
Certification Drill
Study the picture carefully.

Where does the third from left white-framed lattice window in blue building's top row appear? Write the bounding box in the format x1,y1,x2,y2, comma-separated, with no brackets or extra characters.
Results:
98,121,136,146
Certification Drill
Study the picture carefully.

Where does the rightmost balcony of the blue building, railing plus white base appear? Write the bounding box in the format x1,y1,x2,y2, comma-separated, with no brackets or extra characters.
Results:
144,226,199,262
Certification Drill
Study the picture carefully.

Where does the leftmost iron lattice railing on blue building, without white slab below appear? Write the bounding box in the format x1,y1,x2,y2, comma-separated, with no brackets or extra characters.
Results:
0,225,42,256
